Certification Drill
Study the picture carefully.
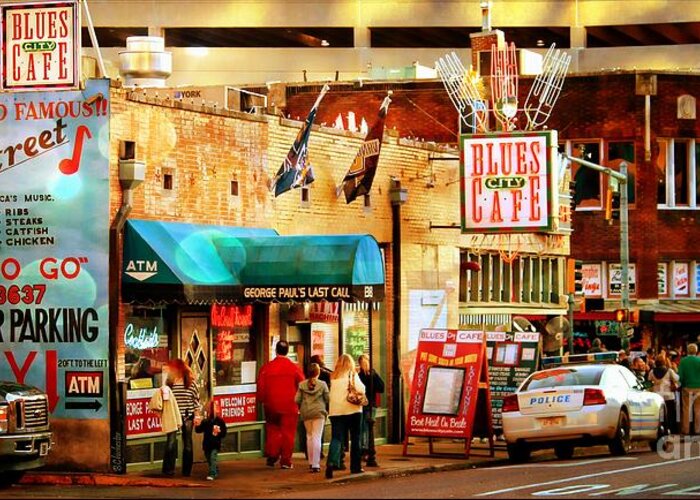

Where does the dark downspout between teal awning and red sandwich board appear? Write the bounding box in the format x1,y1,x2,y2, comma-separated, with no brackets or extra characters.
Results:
389,177,408,443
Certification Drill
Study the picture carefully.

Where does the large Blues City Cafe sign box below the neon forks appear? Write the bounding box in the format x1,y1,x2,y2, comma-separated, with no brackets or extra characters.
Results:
460,131,557,233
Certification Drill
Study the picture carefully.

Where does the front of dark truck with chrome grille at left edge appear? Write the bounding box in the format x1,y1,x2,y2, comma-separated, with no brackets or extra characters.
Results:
0,380,52,482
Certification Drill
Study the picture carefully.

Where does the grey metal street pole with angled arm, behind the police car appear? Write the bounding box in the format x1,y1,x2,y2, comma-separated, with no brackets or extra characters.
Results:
562,154,630,350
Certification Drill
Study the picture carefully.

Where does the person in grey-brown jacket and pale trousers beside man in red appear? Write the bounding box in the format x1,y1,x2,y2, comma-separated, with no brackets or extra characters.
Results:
295,363,330,472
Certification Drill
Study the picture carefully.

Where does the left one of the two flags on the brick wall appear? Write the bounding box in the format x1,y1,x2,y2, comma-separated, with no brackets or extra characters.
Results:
270,85,329,197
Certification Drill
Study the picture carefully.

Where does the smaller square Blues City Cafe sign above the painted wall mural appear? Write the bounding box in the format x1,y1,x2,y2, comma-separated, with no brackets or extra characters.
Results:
0,0,80,90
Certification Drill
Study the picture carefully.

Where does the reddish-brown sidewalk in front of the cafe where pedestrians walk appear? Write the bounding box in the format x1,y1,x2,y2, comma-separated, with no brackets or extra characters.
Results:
21,438,506,498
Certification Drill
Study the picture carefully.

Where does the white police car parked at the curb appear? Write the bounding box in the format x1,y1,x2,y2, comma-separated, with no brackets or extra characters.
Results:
502,352,668,462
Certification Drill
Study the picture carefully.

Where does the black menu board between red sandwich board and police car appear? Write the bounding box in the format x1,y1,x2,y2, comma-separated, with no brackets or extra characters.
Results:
486,332,540,434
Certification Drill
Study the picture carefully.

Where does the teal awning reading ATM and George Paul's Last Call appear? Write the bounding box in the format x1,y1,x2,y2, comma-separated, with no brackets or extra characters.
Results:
122,219,384,304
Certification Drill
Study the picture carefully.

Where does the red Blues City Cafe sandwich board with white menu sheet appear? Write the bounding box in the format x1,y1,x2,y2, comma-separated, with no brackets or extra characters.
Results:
403,329,494,457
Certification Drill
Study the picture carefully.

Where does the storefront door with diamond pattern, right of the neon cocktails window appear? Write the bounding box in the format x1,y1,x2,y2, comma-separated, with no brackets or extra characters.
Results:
180,313,210,462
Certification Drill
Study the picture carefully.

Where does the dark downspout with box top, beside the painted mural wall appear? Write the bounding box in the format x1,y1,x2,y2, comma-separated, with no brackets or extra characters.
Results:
109,159,145,474
